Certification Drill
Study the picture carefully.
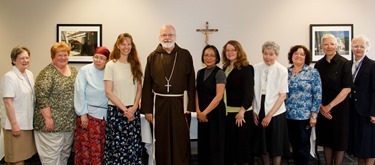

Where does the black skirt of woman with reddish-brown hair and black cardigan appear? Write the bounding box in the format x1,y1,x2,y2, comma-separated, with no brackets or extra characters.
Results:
225,111,254,164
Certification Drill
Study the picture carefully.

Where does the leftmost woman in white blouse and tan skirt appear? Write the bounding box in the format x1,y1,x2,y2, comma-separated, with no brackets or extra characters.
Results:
0,46,36,164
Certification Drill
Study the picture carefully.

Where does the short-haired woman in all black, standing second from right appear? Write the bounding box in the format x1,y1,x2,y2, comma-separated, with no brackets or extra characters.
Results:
315,34,352,164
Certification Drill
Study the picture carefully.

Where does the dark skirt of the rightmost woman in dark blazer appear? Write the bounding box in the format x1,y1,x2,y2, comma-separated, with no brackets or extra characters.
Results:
348,104,375,158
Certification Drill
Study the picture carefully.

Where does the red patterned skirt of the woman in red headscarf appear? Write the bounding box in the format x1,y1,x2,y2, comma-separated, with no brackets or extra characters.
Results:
74,115,106,165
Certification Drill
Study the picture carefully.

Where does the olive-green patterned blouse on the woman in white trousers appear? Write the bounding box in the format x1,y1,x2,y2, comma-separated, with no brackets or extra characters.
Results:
34,64,77,132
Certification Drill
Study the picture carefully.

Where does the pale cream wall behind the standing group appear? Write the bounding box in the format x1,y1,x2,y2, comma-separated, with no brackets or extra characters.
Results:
0,0,375,76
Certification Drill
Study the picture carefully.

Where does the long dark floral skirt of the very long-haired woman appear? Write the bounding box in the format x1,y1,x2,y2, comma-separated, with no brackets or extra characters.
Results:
104,105,142,165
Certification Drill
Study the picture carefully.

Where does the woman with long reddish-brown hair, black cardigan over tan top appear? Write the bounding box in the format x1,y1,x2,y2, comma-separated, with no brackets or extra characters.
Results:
222,40,254,164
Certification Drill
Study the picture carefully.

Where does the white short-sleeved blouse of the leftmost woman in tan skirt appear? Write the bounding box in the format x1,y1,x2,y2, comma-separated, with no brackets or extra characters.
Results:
0,66,35,130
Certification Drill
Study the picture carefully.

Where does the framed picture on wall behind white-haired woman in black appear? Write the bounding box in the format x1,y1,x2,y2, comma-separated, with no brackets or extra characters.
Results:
310,24,353,62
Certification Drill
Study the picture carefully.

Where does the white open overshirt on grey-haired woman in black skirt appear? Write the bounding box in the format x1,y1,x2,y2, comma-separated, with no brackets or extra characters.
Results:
253,61,289,116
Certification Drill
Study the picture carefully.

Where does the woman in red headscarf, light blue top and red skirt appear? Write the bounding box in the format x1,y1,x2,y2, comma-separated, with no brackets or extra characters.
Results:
74,47,110,165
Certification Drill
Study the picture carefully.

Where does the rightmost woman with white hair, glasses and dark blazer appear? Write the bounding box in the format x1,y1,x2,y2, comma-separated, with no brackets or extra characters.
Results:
348,35,375,165
